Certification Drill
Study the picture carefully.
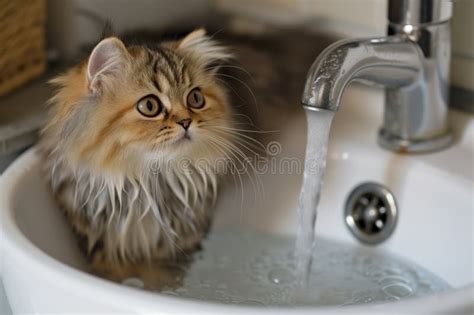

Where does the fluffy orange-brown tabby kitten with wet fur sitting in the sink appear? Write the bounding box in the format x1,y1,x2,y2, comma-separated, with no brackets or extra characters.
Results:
41,29,233,276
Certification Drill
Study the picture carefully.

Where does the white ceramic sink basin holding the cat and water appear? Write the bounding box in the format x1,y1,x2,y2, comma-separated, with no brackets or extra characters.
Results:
0,86,474,314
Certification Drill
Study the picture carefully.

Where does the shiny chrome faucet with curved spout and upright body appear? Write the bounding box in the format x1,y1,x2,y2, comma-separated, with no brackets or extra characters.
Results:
302,0,452,152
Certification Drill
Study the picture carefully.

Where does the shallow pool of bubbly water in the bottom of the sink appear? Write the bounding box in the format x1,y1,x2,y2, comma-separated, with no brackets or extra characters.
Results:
123,229,450,306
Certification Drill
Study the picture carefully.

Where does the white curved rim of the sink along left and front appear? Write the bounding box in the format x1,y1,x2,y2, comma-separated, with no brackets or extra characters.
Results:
0,148,474,314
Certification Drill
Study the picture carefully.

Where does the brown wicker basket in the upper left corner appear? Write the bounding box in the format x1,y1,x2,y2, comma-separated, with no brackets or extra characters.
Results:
0,0,46,95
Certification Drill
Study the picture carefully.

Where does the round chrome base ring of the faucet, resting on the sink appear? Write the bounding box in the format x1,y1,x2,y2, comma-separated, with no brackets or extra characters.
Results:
378,129,453,153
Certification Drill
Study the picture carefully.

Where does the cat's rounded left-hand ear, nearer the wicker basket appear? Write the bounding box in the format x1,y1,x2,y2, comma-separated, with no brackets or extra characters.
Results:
87,37,128,93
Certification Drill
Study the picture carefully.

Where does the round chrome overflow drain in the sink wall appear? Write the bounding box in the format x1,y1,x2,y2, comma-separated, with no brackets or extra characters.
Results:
345,183,397,244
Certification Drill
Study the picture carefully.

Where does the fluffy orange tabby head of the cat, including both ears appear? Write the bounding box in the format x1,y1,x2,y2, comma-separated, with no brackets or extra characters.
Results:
45,30,232,175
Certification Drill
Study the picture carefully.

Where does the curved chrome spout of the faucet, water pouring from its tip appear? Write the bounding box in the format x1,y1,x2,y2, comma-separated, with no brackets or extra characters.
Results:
302,35,423,111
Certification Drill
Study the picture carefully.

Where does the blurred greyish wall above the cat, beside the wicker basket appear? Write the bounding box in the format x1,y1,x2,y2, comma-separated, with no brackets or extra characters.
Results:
48,0,213,57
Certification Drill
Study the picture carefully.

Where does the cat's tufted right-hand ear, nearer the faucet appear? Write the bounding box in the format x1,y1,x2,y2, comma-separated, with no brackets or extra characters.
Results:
177,28,233,66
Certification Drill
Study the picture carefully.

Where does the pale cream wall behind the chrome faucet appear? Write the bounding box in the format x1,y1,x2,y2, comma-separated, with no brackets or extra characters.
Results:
215,0,474,90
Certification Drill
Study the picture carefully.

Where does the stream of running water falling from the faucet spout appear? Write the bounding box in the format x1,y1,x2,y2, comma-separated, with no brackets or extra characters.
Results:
296,110,334,292
